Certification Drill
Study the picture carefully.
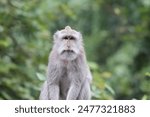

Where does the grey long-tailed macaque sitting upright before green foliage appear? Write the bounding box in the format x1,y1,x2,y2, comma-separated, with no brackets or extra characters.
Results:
40,26,92,100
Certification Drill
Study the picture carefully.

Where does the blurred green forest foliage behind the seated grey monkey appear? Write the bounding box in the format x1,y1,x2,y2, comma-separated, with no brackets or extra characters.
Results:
0,0,150,99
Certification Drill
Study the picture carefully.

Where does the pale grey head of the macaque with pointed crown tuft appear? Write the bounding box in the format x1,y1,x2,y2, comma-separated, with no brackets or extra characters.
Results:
53,26,83,61
